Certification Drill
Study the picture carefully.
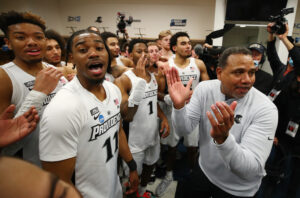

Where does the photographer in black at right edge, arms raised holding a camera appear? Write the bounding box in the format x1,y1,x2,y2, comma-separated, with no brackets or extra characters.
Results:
258,23,300,198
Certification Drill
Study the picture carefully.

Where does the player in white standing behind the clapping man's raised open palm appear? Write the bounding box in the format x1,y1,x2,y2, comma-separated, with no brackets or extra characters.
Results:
156,32,209,196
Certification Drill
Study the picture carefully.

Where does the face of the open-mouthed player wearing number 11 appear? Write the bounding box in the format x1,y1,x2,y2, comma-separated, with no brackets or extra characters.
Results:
70,33,109,86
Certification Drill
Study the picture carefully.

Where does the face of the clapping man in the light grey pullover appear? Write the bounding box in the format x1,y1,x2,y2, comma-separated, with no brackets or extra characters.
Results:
217,54,256,98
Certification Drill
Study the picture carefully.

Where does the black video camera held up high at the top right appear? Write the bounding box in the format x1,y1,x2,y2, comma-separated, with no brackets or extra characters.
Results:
269,8,294,34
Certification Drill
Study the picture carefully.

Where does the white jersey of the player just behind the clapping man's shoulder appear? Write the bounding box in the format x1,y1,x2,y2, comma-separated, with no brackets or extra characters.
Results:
169,58,200,90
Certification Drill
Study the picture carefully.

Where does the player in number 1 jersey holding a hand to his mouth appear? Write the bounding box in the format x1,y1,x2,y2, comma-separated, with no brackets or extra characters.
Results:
115,39,169,197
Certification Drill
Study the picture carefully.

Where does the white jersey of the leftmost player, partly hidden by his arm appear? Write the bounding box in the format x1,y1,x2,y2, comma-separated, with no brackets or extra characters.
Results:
1,62,68,166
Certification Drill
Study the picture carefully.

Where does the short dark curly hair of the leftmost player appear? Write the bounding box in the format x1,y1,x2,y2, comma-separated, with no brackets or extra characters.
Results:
0,10,46,38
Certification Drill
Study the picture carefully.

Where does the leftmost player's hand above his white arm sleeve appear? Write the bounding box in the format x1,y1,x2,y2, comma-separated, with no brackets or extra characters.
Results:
33,67,63,95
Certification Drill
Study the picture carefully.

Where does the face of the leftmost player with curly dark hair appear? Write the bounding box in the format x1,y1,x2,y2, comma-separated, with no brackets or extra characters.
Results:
5,23,46,64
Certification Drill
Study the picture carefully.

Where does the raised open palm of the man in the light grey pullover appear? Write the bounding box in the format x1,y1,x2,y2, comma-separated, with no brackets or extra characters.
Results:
167,67,193,109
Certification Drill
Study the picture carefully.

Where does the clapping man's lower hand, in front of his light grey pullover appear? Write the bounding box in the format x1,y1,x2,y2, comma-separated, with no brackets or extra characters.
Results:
206,101,237,144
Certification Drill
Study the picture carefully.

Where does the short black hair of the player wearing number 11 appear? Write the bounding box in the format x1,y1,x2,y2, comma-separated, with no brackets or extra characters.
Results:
66,29,112,72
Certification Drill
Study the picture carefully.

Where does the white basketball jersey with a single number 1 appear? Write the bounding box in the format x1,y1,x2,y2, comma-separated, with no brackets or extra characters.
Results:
125,70,159,153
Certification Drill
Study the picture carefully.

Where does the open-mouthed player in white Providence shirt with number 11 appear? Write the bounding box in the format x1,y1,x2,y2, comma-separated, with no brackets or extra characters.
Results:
40,30,138,198
